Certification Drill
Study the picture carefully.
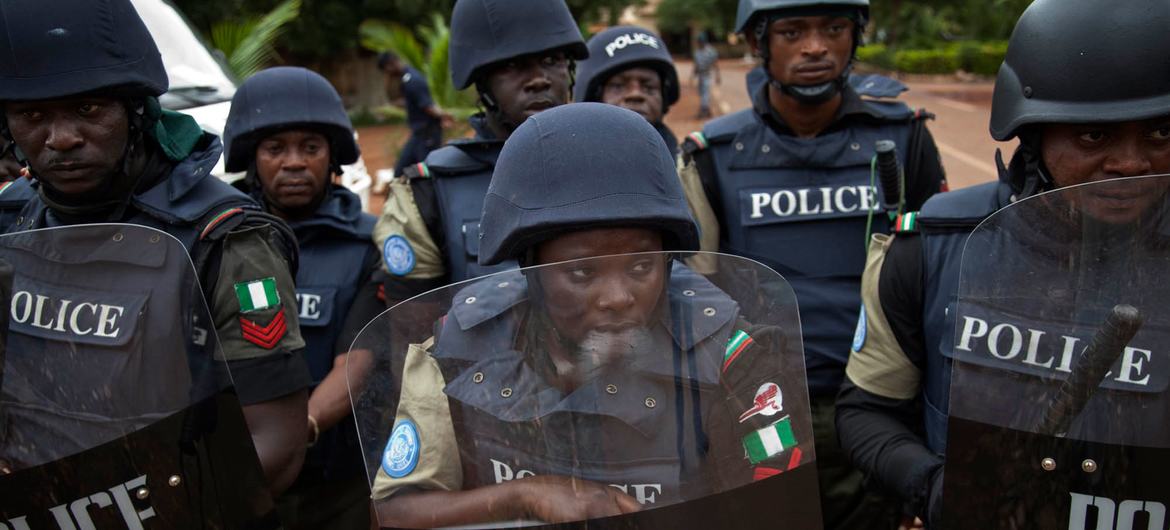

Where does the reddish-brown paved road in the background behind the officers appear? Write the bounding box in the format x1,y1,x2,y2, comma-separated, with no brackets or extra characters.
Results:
667,60,1013,188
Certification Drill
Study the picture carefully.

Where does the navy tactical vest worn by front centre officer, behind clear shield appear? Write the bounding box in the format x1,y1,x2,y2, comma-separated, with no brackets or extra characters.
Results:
433,266,738,504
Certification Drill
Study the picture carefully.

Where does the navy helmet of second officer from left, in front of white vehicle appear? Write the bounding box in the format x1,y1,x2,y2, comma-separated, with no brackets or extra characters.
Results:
223,67,360,172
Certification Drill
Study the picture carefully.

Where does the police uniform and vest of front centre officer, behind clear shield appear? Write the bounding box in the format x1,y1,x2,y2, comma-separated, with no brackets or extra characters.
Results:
373,264,810,504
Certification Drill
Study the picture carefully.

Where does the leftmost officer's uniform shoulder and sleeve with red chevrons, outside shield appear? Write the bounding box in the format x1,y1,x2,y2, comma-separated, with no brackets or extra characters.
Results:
8,133,309,405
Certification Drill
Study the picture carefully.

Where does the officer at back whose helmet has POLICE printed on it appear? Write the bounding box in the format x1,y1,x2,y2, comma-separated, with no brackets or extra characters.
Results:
573,26,679,154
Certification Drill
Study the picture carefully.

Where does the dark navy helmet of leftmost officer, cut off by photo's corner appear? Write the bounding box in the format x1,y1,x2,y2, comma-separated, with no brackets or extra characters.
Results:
0,0,168,101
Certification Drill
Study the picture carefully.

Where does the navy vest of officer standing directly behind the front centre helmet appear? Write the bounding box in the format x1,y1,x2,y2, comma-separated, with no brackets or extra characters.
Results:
408,139,516,283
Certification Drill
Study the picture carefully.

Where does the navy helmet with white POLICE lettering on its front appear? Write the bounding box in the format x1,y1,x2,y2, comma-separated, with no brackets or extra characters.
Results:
573,26,679,110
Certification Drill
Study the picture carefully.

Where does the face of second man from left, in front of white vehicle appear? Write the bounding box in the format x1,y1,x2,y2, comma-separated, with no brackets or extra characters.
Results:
256,130,330,218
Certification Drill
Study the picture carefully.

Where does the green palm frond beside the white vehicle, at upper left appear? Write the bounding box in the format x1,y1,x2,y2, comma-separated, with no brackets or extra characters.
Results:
211,0,301,80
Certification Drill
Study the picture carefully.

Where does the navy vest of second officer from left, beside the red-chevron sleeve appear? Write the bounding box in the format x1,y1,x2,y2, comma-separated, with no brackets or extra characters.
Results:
289,186,376,385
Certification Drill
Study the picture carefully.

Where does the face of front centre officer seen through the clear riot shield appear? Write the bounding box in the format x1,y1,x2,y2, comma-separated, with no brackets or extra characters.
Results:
536,228,668,367
